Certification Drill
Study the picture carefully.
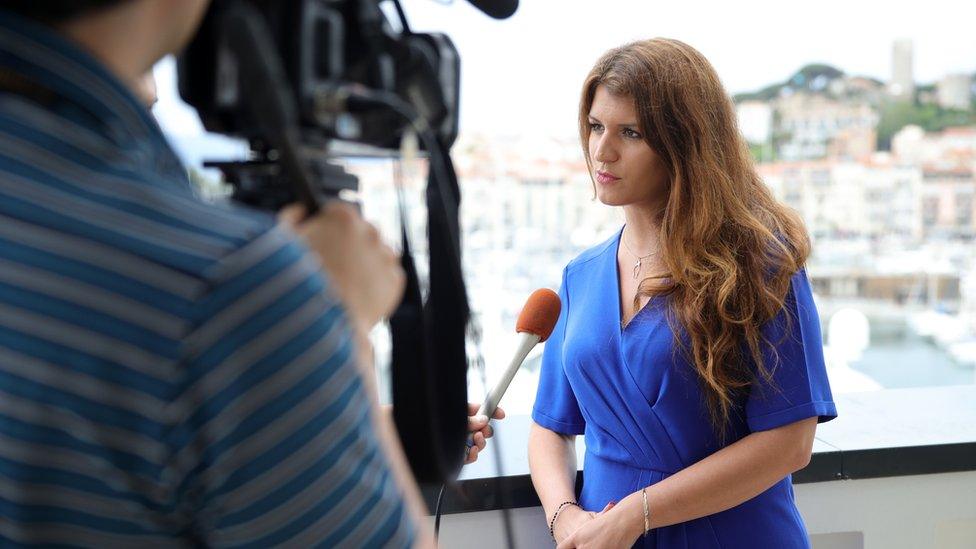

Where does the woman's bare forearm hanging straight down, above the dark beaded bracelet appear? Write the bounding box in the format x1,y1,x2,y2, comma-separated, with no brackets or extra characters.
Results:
529,423,576,518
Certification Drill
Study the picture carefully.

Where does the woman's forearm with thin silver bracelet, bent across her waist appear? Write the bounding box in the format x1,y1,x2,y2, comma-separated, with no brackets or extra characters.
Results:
612,418,817,534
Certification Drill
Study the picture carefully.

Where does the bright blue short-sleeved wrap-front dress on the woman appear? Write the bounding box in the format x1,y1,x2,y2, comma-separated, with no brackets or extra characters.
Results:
532,226,837,549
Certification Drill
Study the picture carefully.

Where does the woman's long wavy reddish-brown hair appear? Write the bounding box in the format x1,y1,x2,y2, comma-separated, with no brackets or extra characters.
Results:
579,38,810,440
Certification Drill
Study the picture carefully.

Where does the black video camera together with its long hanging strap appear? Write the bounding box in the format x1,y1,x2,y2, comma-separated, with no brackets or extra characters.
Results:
178,0,517,482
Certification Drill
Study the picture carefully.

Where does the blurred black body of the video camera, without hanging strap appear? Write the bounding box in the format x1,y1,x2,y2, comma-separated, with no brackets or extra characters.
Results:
179,0,460,151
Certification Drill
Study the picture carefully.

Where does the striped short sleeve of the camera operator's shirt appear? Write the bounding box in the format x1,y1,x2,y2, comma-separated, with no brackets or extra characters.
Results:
174,225,414,547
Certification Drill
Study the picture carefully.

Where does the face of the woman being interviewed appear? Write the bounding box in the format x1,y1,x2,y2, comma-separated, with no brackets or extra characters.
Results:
588,84,668,209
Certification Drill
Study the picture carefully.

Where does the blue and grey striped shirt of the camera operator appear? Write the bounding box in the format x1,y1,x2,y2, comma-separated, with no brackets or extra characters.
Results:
0,12,414,547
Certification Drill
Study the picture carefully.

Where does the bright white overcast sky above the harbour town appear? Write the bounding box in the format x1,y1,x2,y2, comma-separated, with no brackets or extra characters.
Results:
156,0,976,150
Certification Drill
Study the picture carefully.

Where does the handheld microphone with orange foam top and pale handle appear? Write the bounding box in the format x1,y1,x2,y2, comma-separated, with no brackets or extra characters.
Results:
467,288,562,448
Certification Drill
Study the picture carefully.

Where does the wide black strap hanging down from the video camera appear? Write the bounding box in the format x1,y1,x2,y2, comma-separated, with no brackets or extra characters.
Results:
390,134,469,483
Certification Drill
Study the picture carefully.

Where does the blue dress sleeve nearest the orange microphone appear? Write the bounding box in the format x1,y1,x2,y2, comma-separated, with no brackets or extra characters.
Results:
532,271,586,435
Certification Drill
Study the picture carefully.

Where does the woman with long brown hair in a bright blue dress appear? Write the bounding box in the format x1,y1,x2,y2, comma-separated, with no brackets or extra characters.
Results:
529,39,837,549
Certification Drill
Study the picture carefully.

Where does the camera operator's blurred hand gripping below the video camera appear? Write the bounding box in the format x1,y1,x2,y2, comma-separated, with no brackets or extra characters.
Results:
278,200,405,334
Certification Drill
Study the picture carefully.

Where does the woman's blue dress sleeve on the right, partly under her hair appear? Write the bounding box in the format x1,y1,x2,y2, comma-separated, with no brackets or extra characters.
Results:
745,270,837,432
